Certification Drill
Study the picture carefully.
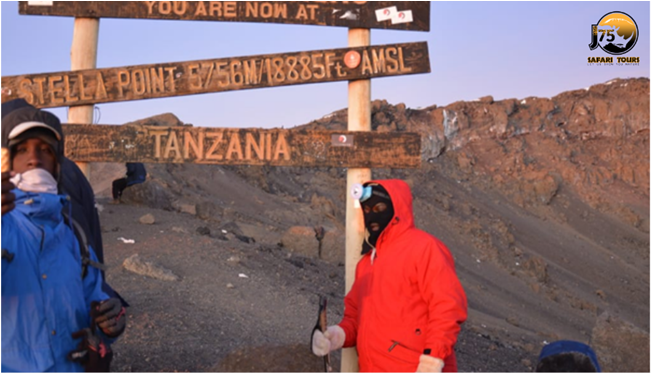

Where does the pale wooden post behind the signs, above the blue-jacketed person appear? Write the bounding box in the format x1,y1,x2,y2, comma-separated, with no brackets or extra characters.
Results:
68,18,100,181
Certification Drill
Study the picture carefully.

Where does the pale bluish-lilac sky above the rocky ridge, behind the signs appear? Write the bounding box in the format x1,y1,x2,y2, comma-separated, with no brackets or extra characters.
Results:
0,1,650,128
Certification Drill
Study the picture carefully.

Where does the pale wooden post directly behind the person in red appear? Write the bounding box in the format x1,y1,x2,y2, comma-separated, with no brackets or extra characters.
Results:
341,29,371,373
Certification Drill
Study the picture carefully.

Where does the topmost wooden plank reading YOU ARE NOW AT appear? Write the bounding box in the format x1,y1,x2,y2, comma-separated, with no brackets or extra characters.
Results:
18,1,430,31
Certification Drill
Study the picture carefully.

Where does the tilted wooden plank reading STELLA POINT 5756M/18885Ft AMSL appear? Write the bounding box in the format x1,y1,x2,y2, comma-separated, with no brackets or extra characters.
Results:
2,42,430,108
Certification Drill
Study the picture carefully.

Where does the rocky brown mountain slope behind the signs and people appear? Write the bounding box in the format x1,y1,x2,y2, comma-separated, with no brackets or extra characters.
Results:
92,78,650,371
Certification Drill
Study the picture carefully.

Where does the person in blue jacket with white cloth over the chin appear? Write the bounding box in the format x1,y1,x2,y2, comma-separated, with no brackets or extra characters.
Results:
1,107,126,372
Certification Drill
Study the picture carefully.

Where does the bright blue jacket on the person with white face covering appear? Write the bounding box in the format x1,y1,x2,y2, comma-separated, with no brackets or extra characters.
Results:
2,189,108,372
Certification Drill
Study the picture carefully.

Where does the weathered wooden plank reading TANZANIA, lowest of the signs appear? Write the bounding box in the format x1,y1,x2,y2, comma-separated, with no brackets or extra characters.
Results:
63,125,421,168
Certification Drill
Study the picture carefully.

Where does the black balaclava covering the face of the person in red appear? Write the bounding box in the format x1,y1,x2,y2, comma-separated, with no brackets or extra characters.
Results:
361,184,394,254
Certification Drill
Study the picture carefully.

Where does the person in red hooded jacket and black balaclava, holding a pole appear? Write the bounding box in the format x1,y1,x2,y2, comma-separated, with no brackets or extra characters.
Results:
311,180,467,372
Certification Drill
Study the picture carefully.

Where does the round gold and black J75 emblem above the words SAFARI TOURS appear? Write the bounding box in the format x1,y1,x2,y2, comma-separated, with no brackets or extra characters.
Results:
589,12,638,55
